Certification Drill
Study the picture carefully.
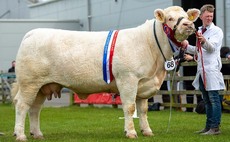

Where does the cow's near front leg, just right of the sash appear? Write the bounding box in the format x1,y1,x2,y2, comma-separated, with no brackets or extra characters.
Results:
116,75,138,138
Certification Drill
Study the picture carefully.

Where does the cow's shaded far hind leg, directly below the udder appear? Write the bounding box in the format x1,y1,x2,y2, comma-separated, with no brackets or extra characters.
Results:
29,92,46,139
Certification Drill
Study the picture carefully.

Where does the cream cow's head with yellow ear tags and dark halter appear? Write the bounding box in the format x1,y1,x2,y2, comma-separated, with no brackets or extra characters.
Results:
154,6,200,42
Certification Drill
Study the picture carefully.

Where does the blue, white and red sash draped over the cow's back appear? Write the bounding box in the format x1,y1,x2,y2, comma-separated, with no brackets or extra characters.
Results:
103,30,119,84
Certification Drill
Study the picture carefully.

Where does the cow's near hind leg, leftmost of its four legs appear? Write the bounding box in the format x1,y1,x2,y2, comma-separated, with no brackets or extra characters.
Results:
14,90,36,141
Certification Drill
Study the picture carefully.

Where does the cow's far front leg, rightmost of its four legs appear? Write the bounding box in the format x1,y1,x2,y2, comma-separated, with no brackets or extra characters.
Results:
136,99,153,136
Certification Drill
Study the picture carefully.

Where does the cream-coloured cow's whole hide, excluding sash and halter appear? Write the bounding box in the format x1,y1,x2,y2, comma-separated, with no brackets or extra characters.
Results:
12,6,199,141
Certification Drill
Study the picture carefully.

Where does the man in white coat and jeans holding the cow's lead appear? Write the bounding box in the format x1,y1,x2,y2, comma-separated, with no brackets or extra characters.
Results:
184,4,225,135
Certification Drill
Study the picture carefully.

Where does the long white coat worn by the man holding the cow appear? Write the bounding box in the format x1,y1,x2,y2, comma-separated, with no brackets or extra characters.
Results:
187,23,225,91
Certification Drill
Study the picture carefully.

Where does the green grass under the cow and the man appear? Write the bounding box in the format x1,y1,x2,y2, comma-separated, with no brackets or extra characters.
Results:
0,104,230,142
